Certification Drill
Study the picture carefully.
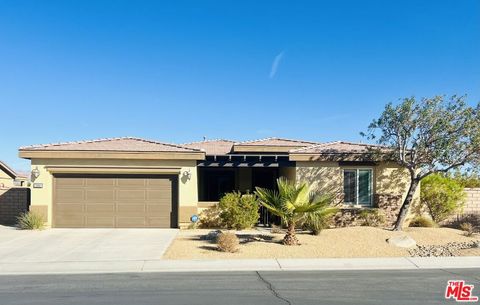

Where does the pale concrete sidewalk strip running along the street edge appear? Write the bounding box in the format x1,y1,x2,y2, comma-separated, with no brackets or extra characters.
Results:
0,256,480,275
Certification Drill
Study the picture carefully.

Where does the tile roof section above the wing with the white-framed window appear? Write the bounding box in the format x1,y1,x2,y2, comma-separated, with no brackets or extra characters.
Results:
290,141,384,154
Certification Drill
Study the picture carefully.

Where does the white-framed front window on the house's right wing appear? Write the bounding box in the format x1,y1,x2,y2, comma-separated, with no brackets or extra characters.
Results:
343,169,372,205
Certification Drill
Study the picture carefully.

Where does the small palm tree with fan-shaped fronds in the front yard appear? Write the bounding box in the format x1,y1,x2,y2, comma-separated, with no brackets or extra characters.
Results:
255,177,331,246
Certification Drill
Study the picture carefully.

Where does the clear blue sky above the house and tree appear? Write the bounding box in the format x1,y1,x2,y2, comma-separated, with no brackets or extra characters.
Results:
0,0,480,170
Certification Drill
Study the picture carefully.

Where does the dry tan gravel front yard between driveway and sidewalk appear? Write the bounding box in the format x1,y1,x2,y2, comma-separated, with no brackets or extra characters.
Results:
164,227,475,259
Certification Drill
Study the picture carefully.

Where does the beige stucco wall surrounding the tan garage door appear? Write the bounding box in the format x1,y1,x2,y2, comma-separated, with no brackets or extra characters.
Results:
31,159,198,226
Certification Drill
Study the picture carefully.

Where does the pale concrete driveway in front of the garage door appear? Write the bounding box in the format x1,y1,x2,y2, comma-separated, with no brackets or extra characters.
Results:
0,226,178,263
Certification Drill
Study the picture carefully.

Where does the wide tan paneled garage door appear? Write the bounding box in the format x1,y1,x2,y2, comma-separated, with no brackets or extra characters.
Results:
53,175,177,228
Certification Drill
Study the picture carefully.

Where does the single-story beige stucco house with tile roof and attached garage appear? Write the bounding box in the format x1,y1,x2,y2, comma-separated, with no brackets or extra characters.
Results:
19,137,416,228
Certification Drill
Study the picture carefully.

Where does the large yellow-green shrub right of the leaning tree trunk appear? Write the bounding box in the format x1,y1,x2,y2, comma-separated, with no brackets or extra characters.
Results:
420,174,466,223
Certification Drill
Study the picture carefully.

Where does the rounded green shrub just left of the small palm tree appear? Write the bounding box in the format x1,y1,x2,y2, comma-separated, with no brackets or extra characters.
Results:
218,192,260,230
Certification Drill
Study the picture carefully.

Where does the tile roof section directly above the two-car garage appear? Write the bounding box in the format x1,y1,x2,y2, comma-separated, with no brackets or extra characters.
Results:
20,137,200,152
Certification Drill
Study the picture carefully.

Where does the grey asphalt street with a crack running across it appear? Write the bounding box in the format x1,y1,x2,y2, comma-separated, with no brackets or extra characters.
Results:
0,269,480,305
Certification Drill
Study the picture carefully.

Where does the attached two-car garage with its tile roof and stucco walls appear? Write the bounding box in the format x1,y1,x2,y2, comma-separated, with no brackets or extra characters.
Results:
19,137,205,228
